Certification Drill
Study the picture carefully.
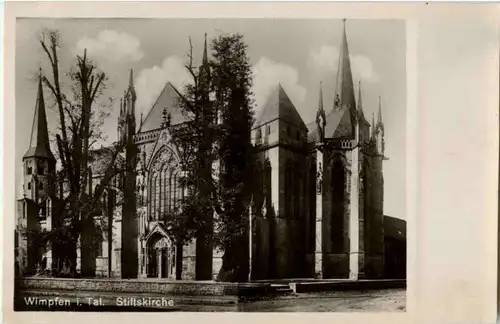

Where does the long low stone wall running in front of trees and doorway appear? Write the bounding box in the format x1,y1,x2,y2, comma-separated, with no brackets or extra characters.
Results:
17,277,271,296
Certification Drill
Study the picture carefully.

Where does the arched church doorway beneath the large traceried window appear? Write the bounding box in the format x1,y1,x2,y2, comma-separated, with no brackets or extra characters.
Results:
146,232,175,279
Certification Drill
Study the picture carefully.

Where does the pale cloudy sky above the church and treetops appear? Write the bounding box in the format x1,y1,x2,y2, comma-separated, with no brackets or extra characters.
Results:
16,19,406,218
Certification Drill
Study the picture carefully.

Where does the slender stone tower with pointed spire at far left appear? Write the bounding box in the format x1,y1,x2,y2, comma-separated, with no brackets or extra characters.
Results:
16,72,56,275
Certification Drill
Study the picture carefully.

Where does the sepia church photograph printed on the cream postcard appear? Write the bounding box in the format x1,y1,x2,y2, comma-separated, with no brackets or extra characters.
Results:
12,17,407,312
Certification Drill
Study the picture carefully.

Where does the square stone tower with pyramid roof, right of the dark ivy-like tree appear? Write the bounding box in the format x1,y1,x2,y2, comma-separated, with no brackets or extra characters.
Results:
252,84,307,278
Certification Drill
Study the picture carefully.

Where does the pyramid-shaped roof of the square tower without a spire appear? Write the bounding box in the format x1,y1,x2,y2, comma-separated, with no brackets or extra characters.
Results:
254,84,307,129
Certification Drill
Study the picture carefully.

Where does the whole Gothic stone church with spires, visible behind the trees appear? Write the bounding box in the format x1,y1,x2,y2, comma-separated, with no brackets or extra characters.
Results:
16,20,385,280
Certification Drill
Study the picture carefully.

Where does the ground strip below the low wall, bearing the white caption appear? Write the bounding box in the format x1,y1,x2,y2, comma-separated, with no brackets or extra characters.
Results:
16,289,406,312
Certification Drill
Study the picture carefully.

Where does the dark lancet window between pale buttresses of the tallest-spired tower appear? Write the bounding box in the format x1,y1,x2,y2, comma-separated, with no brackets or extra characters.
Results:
331,161,346,253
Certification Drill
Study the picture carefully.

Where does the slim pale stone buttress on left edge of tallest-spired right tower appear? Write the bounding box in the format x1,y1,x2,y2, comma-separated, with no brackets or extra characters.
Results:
314,149,324,278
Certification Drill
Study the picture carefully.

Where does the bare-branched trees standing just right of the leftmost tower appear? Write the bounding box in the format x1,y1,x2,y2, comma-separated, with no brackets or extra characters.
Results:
40,30,124,276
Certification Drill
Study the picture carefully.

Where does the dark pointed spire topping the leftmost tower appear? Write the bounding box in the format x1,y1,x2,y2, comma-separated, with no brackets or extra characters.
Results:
24,68,55,160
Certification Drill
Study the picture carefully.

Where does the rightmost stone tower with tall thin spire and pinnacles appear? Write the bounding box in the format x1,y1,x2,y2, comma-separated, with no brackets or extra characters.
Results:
310,19,383,280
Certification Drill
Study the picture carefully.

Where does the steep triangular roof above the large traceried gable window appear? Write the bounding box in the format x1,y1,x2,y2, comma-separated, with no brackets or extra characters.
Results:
139,82,188,132
